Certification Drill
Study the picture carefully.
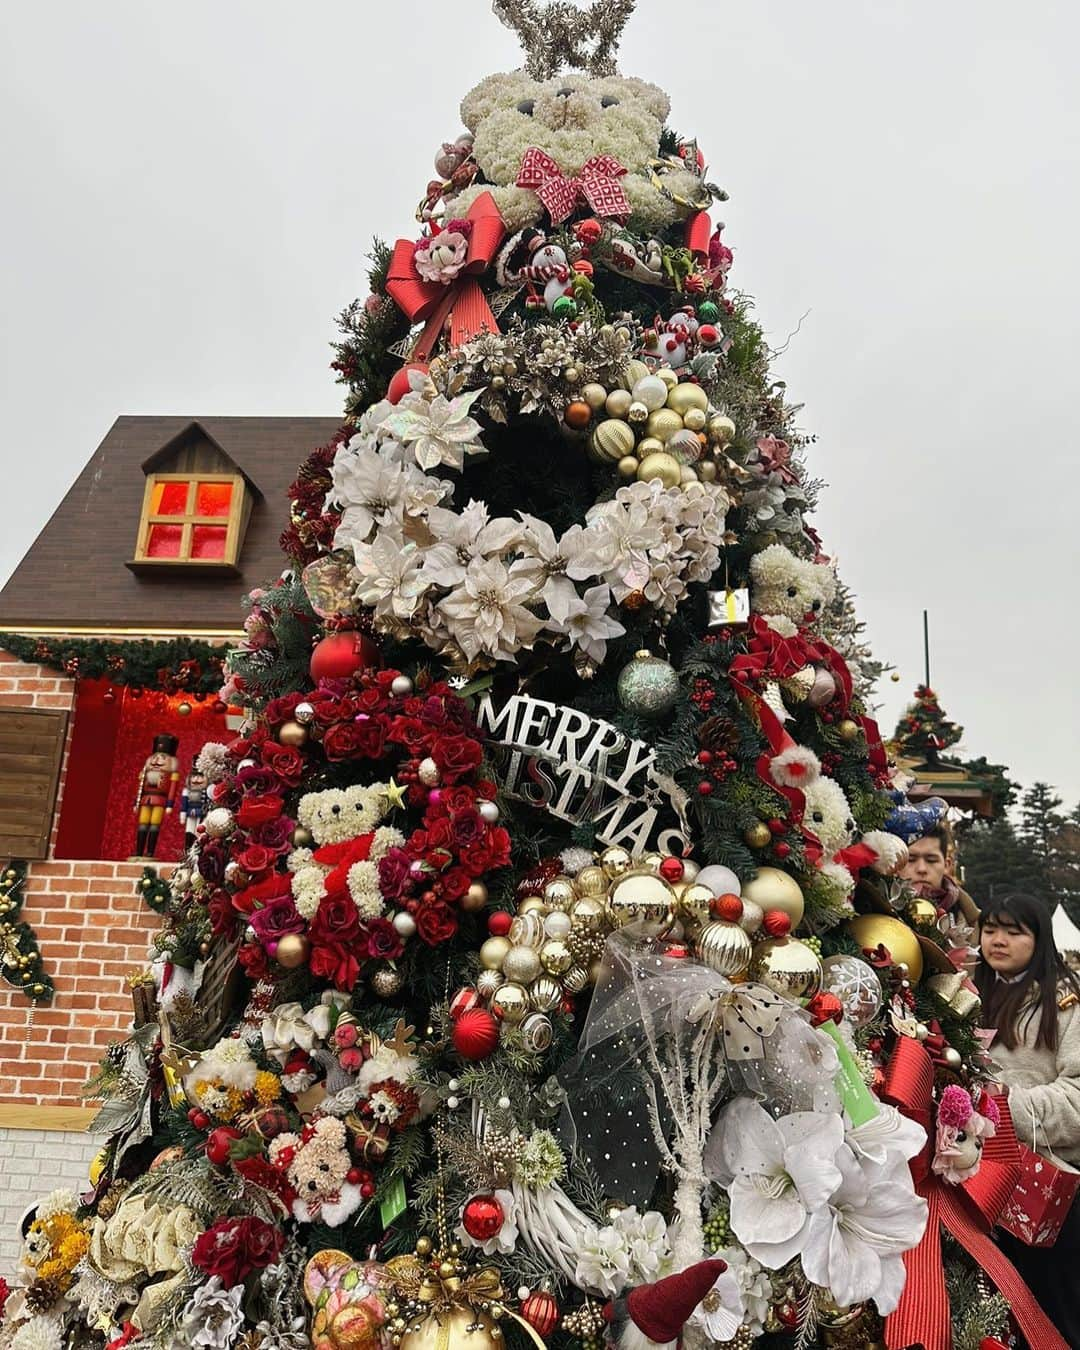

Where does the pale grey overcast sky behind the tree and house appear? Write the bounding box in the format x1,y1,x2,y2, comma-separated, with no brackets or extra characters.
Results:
0,0,1080,802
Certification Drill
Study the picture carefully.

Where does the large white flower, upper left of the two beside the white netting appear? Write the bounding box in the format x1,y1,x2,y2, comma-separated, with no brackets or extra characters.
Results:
718,1098,844,1283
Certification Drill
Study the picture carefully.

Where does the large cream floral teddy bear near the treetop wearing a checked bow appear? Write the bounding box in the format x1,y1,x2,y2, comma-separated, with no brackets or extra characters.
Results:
447,70,702,235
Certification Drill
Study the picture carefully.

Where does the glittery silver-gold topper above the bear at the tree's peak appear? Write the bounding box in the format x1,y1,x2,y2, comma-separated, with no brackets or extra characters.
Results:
491,0,637,80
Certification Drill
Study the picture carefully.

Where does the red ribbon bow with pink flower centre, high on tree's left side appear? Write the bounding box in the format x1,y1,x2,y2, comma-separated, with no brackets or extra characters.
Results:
386,192,506,360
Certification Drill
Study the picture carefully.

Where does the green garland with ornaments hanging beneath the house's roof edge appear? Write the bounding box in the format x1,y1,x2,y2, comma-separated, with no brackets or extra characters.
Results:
0,633,225,695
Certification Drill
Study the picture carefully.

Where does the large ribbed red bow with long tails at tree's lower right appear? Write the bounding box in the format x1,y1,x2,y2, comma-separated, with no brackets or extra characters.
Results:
882,1037,1068,1350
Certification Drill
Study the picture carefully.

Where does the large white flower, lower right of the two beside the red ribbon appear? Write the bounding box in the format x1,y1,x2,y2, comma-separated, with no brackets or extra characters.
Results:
802,1145,927,1316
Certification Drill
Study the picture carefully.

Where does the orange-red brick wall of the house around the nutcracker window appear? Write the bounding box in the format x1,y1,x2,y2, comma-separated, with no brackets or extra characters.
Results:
0,651,159,1107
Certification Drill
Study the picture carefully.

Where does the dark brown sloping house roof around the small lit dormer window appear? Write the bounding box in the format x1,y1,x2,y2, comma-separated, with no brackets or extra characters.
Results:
0,417,342,632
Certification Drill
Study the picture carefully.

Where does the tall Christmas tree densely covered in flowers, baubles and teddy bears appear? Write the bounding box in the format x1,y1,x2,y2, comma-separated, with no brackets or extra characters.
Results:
5,0,1054,1350
